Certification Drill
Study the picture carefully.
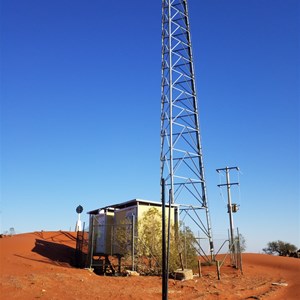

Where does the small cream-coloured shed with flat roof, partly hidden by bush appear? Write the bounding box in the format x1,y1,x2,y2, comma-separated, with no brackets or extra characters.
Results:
88,199,179,261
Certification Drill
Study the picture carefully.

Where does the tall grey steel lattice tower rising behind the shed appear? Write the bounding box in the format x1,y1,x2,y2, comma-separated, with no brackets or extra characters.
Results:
160,0,214,254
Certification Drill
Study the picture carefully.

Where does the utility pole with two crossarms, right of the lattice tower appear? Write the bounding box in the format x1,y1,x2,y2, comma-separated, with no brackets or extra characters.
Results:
216,167,239,266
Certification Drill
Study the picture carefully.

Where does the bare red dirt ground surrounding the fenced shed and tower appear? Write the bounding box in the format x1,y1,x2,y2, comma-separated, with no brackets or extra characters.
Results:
0,231,300,300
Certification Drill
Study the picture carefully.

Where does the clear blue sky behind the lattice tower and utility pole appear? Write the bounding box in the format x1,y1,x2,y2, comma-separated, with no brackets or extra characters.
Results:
0,0,300,252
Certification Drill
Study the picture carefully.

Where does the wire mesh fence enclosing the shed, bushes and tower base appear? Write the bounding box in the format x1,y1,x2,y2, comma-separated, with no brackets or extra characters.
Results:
75,220,242,275
